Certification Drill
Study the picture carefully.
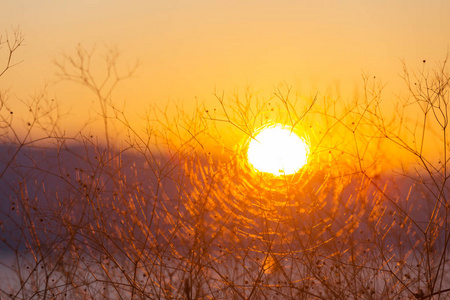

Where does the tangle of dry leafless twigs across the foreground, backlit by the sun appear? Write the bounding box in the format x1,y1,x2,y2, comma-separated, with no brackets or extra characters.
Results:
0,32,450,299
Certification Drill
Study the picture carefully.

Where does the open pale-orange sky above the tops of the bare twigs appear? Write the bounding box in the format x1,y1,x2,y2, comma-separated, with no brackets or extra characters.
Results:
0,0,450,135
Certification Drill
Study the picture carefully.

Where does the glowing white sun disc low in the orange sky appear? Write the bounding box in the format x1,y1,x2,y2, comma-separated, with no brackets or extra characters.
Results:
247,125,309,176
